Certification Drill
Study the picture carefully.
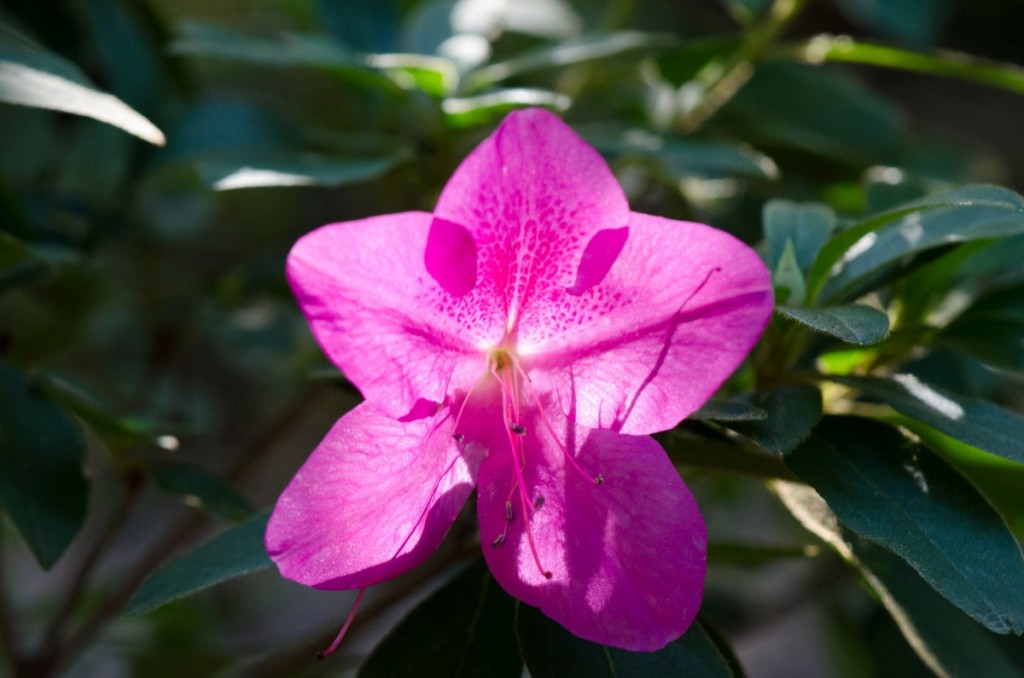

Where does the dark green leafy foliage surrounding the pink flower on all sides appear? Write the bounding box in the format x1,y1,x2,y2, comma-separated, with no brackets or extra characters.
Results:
0,0,1024,676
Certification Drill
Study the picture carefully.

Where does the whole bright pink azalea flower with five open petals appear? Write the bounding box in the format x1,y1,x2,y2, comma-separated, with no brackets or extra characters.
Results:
266,110,772,650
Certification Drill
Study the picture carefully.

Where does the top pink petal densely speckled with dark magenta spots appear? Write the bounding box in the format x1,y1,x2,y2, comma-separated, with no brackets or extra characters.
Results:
434,109,629,332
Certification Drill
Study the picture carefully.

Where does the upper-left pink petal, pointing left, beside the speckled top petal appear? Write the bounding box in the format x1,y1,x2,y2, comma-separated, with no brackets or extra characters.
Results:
288,212,505,417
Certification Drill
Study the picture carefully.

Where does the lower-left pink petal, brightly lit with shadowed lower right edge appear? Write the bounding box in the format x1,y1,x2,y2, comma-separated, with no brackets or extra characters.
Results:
266,402,480,589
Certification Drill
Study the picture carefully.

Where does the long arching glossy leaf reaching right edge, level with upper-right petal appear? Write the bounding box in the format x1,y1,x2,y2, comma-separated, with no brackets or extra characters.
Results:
809,185,1024,300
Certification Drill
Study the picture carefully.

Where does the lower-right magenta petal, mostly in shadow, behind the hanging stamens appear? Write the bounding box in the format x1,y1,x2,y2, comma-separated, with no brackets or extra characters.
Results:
477,399,707,651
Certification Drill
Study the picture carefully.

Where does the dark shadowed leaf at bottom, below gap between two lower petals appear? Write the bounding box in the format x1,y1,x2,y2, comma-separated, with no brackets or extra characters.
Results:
359,559,522,678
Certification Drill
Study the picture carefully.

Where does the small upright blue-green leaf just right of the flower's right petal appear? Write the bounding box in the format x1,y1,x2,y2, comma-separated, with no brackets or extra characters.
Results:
762,200,836,271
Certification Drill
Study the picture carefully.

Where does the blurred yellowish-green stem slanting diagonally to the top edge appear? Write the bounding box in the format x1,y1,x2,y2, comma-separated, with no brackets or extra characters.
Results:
679,0,807,134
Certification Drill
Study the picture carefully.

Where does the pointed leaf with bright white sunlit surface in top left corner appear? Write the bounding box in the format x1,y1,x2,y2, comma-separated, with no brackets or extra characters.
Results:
0,18,165,145
